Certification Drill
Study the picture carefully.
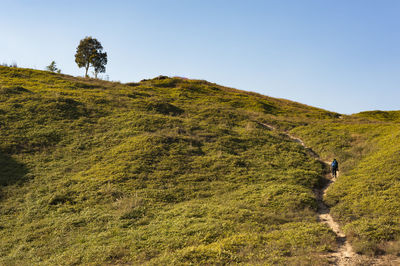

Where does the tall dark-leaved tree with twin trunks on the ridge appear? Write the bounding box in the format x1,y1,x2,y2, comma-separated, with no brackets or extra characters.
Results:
75,36,107,78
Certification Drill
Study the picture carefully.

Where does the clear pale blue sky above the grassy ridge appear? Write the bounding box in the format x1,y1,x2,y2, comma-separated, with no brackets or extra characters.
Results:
0,0,400,114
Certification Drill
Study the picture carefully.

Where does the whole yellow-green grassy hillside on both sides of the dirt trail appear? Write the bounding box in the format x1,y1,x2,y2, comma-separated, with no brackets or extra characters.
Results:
0,67,400,265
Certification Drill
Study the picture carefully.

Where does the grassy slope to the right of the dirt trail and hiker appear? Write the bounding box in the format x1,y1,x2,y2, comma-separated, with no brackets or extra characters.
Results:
292,117,400,256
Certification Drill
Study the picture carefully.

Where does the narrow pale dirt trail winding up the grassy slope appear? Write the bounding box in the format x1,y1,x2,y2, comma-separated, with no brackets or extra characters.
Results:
256,122,400,265
